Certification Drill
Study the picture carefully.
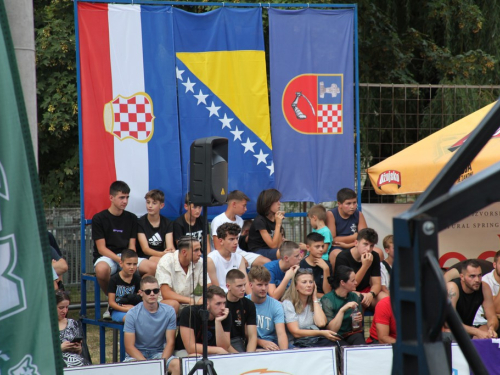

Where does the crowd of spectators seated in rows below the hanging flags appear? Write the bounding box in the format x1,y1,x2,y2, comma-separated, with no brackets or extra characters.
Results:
58,181,500,374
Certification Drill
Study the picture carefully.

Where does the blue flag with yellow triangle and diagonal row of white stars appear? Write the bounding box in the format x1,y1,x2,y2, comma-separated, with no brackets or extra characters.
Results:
173,7,274,213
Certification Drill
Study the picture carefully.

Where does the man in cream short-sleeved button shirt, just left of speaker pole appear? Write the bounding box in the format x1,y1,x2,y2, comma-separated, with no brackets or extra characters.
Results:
156,236,205,314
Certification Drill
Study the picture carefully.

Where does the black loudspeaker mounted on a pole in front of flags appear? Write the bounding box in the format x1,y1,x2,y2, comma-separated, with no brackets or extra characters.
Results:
189,137,228,207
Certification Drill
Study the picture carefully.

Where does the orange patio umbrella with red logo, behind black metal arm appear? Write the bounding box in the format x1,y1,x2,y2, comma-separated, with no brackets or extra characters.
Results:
367,103,500,195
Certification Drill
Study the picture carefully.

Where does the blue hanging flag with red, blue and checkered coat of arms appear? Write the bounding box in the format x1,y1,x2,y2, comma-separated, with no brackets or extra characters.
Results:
269,9,354,203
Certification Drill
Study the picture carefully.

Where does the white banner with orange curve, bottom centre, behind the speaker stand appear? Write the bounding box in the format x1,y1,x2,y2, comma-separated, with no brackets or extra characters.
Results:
182,347,337,375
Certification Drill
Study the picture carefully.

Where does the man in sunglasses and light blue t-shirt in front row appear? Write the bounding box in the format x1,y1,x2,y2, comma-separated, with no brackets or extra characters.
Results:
123,276,180,375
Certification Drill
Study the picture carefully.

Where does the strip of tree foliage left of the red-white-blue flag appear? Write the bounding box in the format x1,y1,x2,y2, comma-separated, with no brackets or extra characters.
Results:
34,0,79,205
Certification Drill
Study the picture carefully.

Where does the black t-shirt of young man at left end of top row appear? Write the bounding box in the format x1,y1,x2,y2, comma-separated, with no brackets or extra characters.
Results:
92,210,137,262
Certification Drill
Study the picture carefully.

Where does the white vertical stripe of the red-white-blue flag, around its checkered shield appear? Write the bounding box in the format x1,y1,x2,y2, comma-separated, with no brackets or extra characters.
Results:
108,5,149,215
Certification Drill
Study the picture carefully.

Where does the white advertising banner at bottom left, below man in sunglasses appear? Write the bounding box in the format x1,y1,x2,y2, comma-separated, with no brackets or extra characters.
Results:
64,359,165,375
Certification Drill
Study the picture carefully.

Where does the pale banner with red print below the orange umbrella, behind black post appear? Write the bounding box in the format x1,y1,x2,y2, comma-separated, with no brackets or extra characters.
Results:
363,203,500,267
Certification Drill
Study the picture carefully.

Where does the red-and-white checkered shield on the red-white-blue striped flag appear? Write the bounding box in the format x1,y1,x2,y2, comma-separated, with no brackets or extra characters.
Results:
104,92,155,142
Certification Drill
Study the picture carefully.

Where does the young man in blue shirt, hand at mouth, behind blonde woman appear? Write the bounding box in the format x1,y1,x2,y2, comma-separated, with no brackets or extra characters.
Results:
264,241,302,300
